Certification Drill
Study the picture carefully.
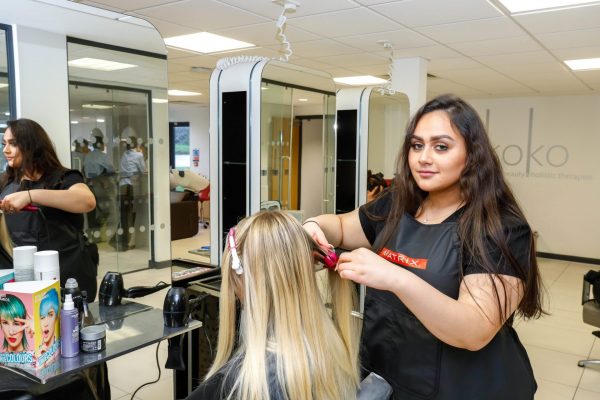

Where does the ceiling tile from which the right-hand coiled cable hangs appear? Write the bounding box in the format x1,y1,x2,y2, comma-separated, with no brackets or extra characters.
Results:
336,29,435,51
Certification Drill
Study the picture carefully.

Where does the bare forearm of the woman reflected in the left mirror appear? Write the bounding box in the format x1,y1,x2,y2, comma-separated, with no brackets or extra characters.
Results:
29,183,96,213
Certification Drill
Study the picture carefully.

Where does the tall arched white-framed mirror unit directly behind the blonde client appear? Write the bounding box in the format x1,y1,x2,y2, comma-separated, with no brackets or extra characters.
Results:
210,59,335,265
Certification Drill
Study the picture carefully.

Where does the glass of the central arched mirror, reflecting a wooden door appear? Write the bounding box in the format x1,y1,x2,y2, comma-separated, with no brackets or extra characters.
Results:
260,79,335,221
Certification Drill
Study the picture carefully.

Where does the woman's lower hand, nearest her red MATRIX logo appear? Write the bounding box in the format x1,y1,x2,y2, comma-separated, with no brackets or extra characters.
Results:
337,247,400,290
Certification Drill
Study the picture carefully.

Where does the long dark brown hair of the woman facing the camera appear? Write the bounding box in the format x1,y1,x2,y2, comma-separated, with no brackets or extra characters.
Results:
377,95,543,323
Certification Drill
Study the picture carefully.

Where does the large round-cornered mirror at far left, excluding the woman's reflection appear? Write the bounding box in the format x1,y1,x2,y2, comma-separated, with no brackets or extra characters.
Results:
0,0,171,278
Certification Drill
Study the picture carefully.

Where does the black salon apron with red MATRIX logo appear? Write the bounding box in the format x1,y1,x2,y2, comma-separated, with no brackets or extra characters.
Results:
361,214,537,400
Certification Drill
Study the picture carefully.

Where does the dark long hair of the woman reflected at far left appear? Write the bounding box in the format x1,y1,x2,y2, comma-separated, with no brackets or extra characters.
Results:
0,118,66,189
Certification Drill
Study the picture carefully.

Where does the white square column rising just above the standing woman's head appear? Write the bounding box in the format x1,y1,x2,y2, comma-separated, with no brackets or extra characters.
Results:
392,57,428,116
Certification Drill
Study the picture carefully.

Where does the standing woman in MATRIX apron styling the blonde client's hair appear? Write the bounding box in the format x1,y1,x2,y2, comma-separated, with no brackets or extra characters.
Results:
304,95,542,400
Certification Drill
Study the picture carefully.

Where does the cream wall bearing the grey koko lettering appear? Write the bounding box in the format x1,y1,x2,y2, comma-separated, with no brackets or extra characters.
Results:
470,95,600,259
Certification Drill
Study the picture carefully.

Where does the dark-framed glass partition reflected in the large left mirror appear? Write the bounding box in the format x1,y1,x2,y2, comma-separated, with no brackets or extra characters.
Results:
68,39,167,275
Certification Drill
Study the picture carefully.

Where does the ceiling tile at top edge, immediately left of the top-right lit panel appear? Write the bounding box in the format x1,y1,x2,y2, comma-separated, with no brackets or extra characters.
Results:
371,0,502,27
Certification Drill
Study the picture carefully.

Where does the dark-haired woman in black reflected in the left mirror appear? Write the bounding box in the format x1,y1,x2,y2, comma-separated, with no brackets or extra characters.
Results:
0,118,98,301
